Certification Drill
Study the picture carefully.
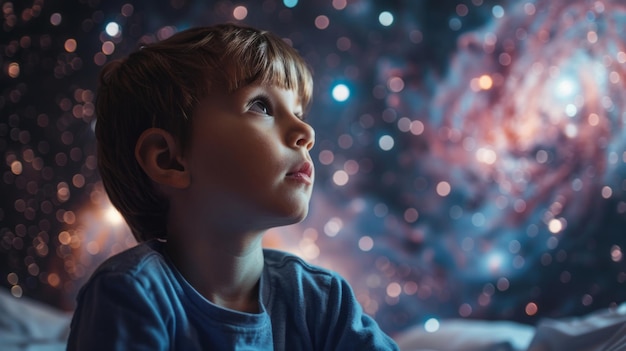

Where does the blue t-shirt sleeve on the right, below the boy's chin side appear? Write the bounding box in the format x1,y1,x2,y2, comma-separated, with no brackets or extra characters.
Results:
316,276,399,351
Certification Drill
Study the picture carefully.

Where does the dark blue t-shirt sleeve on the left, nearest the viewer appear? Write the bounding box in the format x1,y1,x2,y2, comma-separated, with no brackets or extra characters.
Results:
67,273,169,351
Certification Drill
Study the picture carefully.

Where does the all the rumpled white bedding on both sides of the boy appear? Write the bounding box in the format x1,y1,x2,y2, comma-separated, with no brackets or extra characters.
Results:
0,289,626,351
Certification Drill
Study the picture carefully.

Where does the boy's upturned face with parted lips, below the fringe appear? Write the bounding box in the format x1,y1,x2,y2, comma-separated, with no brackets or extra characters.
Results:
184,83,314,230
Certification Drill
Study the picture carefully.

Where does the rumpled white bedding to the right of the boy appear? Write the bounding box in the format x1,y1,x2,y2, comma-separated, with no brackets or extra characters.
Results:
395,303,626,351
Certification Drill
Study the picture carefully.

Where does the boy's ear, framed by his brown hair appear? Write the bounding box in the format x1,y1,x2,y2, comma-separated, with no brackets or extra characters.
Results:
135,128,190,189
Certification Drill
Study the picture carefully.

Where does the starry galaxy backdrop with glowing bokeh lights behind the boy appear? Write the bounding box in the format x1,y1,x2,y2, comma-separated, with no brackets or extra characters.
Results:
0,0,626,333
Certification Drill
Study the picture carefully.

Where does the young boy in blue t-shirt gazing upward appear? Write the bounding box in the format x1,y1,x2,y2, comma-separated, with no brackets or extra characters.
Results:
68,25,397,350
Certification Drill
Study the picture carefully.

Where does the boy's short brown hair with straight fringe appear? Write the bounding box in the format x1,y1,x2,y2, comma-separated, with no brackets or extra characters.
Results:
95,24,313,242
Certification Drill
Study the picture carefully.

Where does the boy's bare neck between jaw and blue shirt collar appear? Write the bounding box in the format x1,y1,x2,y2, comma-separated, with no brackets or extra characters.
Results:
166,233,263,313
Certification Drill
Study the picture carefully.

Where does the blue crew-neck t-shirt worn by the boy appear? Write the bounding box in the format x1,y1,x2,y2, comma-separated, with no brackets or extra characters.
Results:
67,240,398,351
